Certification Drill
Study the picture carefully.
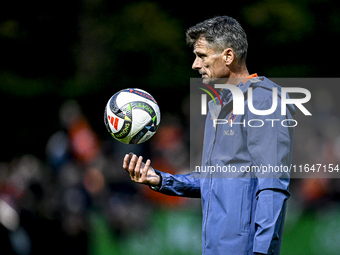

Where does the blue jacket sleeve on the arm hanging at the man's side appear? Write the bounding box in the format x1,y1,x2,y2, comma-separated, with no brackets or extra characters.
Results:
245,94,293,254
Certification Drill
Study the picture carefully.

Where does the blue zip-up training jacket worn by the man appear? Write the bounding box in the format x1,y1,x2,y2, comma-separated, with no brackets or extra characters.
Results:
156,77,295,255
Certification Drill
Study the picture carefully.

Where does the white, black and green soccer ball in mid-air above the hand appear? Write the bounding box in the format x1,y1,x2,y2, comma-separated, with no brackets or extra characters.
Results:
104,88,161,144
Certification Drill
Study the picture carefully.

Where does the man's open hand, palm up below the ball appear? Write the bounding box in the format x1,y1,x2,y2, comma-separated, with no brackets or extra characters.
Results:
123,152,161,186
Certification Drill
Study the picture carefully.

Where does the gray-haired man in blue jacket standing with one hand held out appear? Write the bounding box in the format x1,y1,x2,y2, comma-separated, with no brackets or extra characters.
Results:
123,16,295,255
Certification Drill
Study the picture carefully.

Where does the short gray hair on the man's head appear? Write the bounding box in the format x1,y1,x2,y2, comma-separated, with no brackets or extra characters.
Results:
186,16,248,62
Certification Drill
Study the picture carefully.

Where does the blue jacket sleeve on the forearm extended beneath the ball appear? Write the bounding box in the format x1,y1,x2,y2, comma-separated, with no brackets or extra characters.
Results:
151,169,201,198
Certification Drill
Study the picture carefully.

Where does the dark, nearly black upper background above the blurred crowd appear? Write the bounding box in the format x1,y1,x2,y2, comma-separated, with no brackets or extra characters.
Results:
0,0,340,161
